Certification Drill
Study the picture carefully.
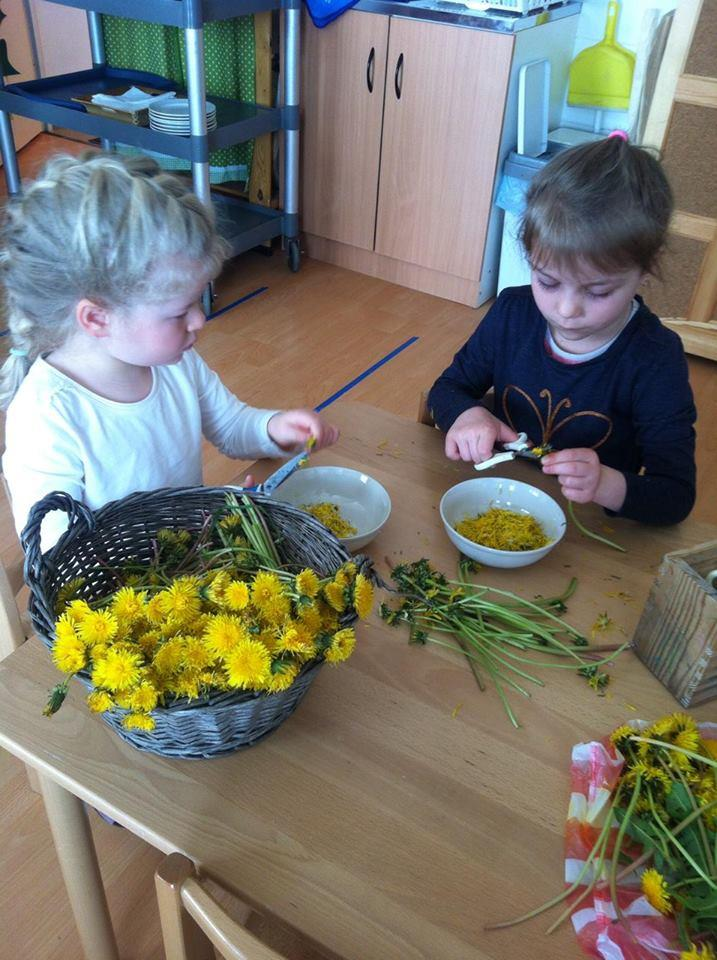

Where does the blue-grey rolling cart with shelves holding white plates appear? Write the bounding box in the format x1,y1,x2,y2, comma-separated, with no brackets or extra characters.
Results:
0,0,301,271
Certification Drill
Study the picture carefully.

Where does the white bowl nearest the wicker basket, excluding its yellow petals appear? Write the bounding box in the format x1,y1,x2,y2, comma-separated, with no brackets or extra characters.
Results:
272,467,391,550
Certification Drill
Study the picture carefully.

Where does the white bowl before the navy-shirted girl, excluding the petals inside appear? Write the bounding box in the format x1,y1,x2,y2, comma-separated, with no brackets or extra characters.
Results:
440,477,566,567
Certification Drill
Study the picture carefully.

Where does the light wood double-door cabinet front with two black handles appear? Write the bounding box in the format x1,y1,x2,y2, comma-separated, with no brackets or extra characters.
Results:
302,11,514,306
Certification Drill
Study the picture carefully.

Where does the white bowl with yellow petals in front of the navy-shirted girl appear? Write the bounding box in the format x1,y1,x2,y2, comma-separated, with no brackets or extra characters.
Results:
440,477,567,567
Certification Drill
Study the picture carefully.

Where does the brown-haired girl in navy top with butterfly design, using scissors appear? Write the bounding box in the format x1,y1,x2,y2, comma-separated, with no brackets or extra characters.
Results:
429,131,696,523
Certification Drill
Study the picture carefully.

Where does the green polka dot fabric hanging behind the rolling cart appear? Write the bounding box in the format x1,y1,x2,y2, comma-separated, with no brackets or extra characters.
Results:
102,16,256,183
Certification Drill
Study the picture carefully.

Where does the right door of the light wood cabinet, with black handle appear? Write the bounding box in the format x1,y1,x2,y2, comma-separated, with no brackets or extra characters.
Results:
376,18,513,280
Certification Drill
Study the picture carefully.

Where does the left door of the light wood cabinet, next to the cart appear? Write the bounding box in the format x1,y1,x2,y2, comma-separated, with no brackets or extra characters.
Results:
301,10,388,250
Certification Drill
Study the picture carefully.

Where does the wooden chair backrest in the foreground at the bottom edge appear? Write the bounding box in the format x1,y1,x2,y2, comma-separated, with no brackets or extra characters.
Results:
154,853,285,960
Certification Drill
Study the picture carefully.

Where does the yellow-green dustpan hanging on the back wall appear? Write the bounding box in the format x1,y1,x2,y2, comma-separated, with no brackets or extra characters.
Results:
568,0,635,110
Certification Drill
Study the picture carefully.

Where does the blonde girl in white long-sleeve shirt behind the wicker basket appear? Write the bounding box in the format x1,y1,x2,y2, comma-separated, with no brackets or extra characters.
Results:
0,153,338,548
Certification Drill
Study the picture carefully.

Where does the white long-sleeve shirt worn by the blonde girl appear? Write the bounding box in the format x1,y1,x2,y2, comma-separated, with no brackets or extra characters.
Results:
2,350,283,550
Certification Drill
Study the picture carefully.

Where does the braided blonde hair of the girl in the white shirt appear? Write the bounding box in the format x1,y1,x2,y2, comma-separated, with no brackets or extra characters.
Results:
0,152,228,409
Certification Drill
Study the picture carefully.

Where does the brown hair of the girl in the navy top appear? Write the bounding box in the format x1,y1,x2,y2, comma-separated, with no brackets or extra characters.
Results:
521,136,673,274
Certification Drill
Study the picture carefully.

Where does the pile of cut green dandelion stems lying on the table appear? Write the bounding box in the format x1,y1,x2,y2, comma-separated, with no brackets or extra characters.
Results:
381,558,627,727
